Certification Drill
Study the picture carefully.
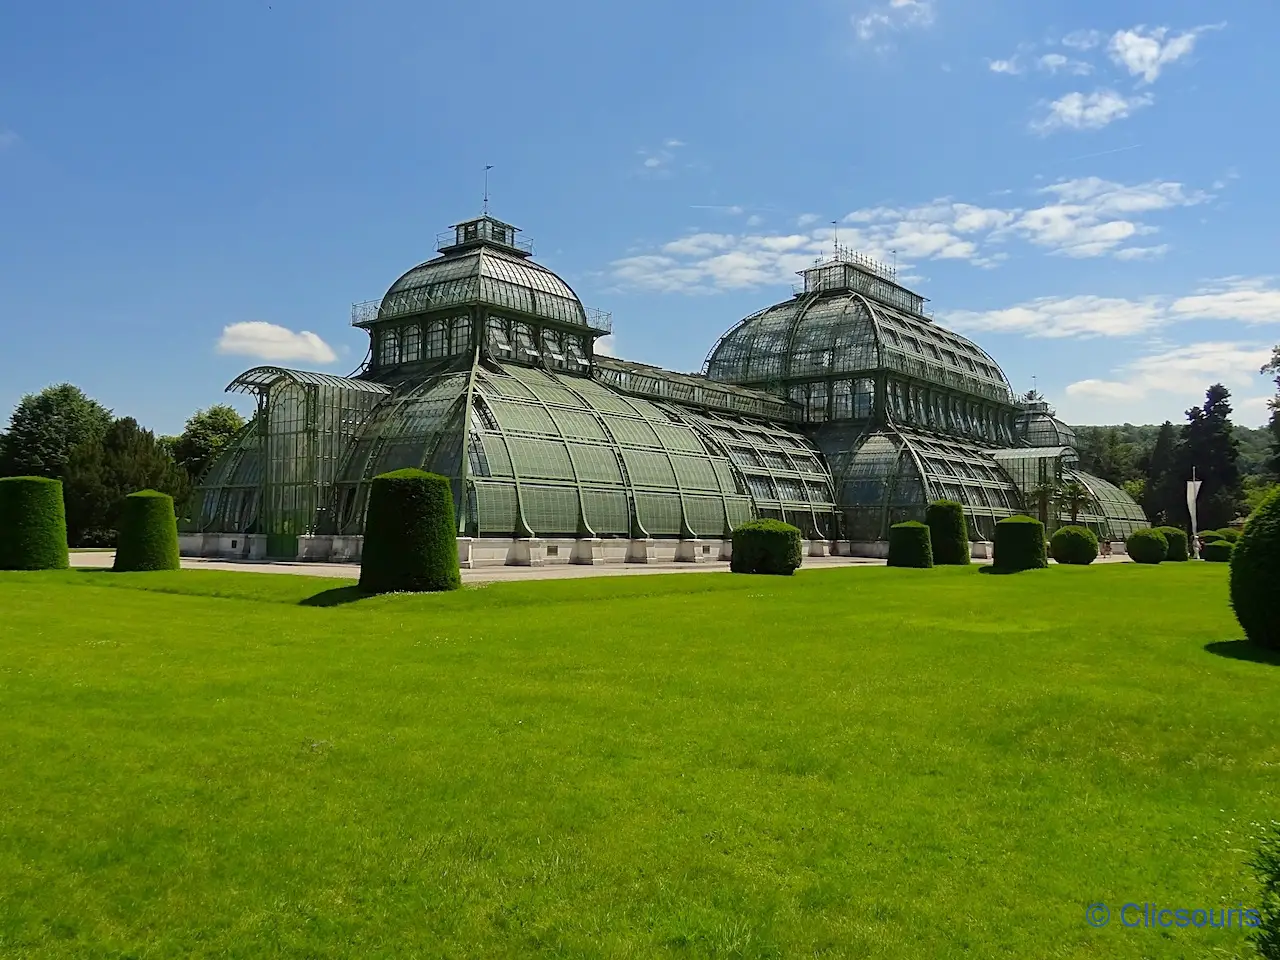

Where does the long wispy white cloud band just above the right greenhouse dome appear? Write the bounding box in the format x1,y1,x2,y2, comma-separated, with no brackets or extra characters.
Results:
612,177,1210,293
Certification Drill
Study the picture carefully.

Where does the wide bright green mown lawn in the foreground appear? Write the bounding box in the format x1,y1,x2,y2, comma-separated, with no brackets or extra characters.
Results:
0,563,1280,959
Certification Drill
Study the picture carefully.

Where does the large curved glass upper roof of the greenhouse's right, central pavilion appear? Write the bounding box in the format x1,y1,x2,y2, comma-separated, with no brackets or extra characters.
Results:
705,291,1012,403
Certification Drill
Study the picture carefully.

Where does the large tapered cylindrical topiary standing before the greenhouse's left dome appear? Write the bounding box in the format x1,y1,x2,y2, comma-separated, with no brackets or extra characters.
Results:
360,468,462,594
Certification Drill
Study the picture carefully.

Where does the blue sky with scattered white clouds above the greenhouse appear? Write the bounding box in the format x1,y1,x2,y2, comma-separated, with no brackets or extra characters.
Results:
0,0,1280,433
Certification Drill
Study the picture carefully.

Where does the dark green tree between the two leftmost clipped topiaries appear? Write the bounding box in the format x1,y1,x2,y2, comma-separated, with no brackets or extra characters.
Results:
64,417,191,545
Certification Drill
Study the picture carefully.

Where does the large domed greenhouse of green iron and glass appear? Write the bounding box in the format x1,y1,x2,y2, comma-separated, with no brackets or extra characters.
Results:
182,215,1146,566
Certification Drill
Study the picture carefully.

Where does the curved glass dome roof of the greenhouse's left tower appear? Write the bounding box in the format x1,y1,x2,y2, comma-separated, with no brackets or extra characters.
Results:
375,246,590,326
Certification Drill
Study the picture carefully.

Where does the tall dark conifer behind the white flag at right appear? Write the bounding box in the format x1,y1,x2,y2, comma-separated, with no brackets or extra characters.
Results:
1165,383,1243,530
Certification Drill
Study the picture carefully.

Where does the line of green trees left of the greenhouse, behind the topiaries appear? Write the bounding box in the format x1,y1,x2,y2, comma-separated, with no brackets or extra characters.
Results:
0,383,244,547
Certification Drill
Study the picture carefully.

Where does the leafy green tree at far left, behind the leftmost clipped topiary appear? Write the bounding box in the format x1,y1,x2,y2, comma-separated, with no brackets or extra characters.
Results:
0,383,111,479
